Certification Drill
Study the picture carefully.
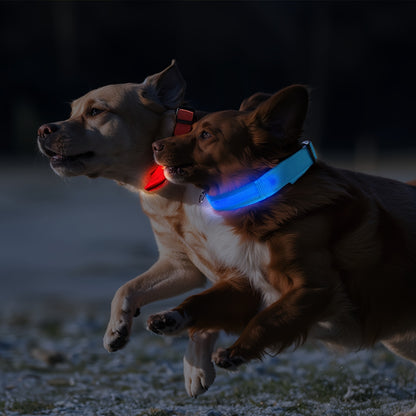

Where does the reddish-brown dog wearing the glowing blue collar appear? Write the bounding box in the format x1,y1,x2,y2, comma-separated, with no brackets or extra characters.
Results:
148,85,416,416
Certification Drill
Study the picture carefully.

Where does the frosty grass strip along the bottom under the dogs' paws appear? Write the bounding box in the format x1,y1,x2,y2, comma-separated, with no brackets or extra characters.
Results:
0,310,416,416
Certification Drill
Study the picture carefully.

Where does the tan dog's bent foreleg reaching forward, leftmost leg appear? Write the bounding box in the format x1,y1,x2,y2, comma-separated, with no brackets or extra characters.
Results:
103,256,206,352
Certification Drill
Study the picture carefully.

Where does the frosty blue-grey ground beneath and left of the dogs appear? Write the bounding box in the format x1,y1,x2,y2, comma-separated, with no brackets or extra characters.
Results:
0,161,416,416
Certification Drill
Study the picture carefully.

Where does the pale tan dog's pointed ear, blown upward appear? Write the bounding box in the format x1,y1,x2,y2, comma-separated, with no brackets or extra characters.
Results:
139,59,186,111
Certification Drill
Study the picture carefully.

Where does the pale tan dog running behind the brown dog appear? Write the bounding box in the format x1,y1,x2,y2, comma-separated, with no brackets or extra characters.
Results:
38,62,270,396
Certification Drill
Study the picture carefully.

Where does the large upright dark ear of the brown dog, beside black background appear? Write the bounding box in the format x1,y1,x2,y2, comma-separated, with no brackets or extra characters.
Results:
249,85,309,146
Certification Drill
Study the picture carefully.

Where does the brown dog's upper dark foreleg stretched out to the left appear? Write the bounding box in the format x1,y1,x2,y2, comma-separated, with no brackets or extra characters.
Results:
147,277,261,335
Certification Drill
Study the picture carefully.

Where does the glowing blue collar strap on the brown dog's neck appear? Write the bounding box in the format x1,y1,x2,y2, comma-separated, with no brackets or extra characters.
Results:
206,141,317,211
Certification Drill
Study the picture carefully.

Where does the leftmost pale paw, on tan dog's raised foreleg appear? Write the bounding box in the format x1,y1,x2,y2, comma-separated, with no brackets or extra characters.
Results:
103,292,140,352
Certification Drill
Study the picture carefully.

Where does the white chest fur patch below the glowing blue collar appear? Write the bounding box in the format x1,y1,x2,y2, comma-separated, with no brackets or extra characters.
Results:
152,186,279,305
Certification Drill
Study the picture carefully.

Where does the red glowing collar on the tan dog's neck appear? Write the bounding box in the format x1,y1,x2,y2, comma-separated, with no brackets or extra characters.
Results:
144,108,195,192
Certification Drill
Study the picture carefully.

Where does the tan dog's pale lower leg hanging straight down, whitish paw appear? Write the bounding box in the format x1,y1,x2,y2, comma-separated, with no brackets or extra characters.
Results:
183,331,218,397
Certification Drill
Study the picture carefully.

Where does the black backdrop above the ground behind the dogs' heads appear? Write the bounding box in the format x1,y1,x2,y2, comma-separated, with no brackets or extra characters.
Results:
0,1,416,155
